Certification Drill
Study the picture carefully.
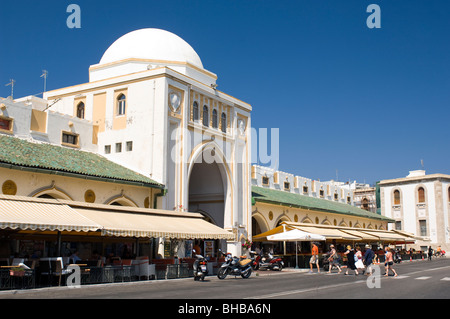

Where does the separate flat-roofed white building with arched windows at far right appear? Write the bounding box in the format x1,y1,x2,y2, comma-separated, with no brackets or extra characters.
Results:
379,170,450,251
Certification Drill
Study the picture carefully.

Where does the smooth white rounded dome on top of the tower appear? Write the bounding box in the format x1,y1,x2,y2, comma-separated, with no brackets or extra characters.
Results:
100,28,203,69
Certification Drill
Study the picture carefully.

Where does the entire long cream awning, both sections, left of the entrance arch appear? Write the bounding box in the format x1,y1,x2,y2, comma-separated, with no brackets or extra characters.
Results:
0,195,235,240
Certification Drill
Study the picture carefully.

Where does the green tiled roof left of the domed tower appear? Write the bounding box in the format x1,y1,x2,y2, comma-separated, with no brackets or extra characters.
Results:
0,134,163,188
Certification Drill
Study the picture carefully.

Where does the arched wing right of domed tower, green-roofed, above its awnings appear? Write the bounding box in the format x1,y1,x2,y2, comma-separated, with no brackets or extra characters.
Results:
252,165,393,238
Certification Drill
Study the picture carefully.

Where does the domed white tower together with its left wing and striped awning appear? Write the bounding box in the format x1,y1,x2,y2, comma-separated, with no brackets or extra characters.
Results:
0,29,251,276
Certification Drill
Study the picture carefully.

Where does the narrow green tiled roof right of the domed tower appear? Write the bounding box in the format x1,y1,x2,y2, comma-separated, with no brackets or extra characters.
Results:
252,186,393,222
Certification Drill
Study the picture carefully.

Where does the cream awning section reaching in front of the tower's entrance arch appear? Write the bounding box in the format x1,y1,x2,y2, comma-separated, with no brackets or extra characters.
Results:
74,208,235,240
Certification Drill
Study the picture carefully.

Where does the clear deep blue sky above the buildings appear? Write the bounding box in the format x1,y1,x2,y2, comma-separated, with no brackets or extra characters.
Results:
0,0,450,183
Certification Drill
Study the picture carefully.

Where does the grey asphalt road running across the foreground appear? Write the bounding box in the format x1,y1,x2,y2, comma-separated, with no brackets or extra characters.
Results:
0,258,450,303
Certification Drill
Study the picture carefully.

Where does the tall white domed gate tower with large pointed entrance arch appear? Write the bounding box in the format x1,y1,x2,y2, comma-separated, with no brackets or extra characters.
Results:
40,29,251,254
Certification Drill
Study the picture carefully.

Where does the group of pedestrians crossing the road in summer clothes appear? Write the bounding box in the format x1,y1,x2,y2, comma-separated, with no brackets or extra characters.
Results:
309,244,398,277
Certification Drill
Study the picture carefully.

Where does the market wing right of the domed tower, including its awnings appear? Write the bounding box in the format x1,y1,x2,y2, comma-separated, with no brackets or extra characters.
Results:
252,165,415,267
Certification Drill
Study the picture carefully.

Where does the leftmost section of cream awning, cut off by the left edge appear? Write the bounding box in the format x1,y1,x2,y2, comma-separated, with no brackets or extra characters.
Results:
0,195,101,232
